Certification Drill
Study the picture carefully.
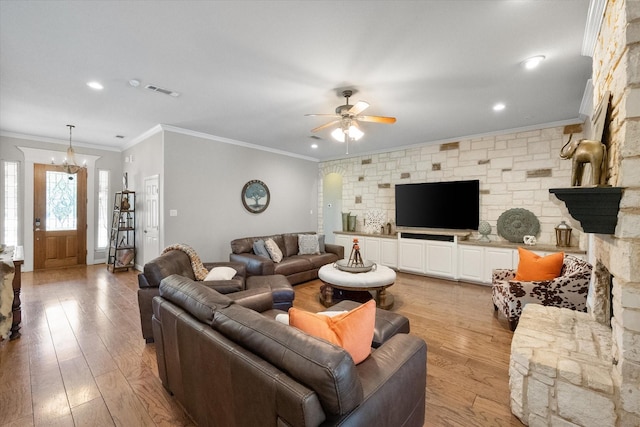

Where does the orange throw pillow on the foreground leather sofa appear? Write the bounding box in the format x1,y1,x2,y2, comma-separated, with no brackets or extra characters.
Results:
289,300,376,364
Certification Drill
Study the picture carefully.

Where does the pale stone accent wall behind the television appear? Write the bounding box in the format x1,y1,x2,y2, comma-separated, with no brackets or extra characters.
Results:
319,127,584,248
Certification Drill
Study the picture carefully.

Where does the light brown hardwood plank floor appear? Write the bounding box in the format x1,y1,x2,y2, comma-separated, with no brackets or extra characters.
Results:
0,265,522,427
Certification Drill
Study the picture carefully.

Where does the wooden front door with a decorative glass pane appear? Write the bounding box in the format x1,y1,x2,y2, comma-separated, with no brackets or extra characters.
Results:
33,164,87,270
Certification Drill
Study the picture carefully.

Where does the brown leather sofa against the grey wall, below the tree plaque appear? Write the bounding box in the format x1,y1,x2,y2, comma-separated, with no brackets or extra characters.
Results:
229,231,344,285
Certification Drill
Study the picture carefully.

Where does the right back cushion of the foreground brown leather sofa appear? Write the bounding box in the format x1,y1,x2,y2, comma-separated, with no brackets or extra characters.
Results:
211,304,363,416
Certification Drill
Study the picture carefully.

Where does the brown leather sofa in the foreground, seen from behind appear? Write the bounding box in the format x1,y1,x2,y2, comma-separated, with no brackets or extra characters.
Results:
153,275,427,427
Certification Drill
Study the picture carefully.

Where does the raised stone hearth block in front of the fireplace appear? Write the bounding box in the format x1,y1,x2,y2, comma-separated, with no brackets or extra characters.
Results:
509,304,617,426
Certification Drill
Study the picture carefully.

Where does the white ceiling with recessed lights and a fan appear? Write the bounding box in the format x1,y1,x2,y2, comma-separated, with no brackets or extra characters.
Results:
0,0,591,160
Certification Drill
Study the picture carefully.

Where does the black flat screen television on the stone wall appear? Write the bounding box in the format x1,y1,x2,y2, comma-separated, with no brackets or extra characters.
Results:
396,180,480,230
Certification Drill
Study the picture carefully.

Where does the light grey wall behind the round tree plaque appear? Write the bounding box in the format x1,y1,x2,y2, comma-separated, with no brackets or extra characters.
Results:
160,131,318,261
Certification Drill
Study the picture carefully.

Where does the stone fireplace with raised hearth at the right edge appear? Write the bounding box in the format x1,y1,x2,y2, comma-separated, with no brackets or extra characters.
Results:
510,0,640,427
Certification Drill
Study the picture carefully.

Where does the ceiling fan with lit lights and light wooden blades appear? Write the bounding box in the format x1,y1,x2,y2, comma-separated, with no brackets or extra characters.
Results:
305,90,396,146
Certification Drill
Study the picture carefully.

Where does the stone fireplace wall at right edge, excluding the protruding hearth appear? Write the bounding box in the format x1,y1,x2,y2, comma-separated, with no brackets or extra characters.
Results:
593,0,640,426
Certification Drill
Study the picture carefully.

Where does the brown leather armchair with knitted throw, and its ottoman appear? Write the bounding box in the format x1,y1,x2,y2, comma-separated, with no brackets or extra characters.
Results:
138,250,295,343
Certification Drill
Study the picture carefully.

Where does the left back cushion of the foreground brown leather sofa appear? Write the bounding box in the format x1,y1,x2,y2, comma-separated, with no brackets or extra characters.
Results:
160,274,232,325
